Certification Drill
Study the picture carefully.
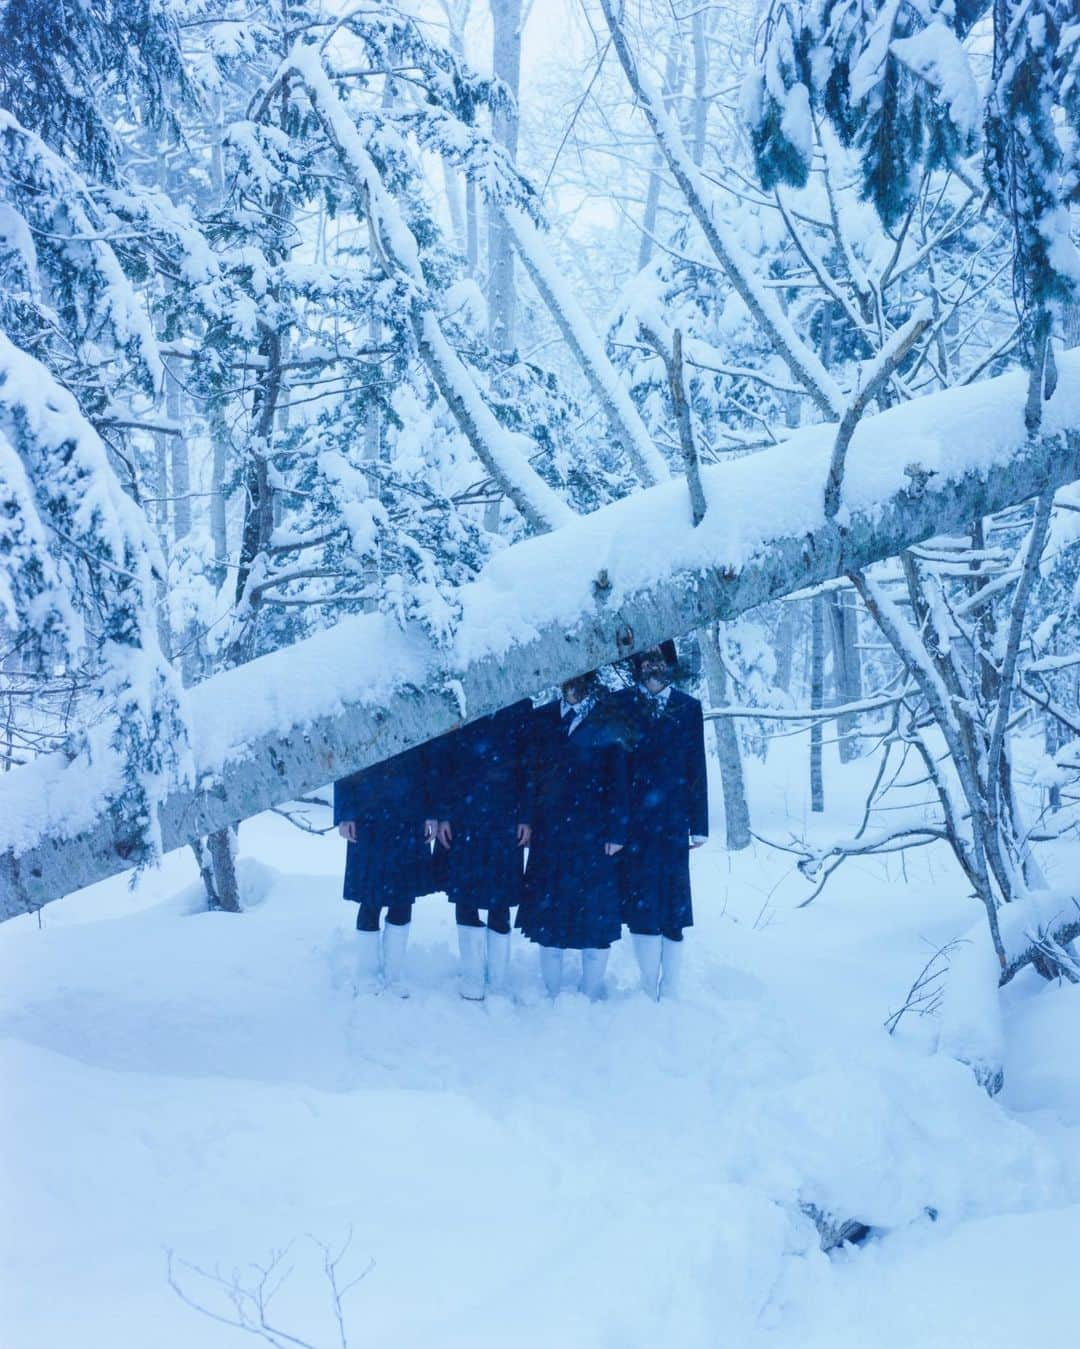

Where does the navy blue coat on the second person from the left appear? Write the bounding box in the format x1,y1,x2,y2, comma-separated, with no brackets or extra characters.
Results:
431,699,533,909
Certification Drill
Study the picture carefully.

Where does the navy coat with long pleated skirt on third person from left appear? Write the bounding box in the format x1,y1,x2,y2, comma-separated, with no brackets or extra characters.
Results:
518,700,628,951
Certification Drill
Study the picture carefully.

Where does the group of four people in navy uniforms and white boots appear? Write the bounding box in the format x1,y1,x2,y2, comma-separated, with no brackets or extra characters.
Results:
334,642,708,1001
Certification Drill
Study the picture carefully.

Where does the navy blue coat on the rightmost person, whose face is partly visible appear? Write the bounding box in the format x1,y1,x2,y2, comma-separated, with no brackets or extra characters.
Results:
615,688,709,936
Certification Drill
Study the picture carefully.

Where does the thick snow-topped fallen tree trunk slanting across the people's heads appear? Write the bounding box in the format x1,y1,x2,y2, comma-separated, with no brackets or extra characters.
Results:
0,353,1080,917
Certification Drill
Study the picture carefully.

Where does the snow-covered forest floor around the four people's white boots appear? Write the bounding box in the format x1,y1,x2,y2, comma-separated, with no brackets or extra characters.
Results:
0,739,1080,1349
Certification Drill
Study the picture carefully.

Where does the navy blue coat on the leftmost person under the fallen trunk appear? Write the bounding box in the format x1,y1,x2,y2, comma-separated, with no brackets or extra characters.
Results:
334,747,434,905
